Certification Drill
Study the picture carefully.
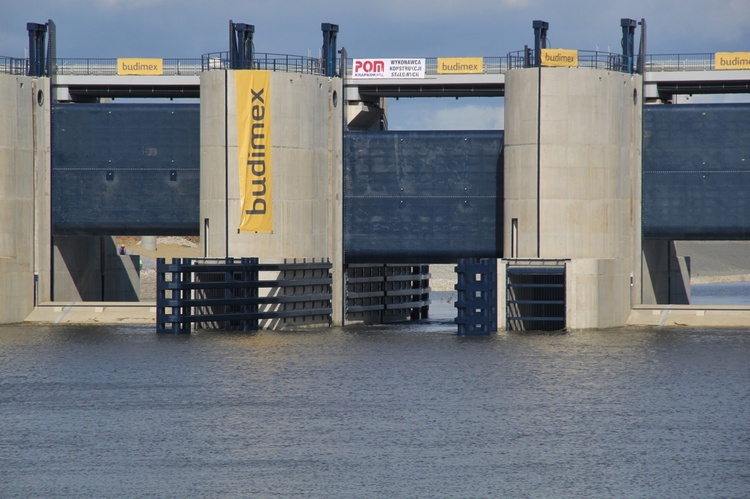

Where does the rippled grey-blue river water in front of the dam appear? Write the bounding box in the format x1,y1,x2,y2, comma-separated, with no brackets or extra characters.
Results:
0,292,750,498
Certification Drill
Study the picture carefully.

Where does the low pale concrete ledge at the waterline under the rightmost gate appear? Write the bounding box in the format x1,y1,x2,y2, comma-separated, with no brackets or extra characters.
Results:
627,305,750,329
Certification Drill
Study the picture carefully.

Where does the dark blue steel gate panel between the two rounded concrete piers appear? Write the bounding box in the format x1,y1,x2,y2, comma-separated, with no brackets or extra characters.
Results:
344,131,503,263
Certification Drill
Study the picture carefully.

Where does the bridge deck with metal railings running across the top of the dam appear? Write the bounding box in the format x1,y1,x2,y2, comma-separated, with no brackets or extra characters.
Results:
0,51,750,102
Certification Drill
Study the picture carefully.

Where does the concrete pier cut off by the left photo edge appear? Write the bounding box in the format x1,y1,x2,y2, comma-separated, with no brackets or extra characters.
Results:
0,75,50,323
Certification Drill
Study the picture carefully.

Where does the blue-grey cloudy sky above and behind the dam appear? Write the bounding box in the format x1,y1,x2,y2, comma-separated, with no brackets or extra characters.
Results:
0,0,750,129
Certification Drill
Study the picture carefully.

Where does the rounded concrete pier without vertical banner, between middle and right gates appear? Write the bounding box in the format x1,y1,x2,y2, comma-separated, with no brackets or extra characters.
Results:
498,68,642,329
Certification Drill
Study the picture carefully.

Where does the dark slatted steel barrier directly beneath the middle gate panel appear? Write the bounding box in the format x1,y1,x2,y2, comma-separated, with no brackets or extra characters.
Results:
346,264,431,324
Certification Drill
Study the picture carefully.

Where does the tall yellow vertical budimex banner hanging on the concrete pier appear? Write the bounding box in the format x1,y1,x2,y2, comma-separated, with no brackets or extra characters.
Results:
234,70,273,232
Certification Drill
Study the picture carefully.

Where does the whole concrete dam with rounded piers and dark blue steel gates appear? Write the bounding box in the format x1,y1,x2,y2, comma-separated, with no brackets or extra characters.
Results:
0,19,750,329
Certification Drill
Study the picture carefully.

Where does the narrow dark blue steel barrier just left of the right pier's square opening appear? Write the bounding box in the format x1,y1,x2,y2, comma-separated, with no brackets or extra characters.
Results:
455,258,497,336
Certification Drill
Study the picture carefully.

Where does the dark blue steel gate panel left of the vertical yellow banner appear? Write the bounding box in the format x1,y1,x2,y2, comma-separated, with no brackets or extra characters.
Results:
52,103,200,235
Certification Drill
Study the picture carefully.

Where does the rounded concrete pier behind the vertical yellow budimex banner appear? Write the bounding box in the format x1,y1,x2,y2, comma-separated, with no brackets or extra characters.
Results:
200,71,343,324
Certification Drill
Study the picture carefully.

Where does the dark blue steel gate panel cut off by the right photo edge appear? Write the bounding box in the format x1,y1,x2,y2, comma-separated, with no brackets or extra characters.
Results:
643,104,750,240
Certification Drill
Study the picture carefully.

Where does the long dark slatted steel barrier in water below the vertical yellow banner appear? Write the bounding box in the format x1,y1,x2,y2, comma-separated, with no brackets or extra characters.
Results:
156,258,332,333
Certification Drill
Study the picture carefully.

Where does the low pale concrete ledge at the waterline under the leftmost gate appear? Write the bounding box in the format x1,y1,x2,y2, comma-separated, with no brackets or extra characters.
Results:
25,302,156,325
